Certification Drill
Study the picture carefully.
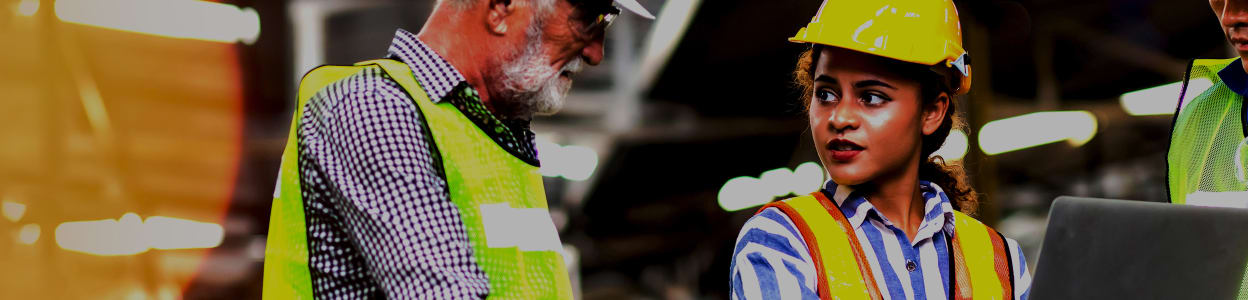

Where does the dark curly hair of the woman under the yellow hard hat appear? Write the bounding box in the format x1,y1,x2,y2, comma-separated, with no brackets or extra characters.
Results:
792,45,980,216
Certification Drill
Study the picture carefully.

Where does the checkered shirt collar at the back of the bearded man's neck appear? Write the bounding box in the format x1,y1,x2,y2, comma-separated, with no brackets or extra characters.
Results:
388,29,464,103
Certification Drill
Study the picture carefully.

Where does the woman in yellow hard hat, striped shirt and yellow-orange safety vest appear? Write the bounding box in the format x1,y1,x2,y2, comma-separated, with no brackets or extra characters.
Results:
730,0,1031,299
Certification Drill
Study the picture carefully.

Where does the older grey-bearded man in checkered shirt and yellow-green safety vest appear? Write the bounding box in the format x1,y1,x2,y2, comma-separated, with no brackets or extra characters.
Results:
263,0,653,299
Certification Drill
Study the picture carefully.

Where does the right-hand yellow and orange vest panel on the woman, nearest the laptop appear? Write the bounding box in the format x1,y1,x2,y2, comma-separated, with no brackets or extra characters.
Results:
950,211,1013,299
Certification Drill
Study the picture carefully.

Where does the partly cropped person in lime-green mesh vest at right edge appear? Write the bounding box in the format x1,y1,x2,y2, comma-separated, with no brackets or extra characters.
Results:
1166,0,1248,208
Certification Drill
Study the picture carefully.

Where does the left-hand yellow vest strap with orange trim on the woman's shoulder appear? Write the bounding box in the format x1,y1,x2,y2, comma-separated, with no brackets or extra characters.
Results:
759,191,882,299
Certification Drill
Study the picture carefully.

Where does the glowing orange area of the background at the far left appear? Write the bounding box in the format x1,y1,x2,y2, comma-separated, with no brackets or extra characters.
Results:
0,4,245,295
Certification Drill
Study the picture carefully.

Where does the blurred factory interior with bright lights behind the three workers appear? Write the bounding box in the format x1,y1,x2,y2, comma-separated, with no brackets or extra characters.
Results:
0,0,1233,299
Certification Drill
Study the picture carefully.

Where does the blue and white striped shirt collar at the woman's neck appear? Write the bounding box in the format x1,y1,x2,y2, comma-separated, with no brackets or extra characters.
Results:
824,180,953,241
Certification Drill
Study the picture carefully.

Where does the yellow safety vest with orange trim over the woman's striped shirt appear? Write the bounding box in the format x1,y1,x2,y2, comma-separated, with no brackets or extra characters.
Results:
759,191,1013,299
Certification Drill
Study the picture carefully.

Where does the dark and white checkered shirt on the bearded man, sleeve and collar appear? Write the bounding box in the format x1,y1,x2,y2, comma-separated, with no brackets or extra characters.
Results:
298,30,538,299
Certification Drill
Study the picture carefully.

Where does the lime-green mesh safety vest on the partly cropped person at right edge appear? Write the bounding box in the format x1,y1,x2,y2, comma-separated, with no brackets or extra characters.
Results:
1166,59,1248,205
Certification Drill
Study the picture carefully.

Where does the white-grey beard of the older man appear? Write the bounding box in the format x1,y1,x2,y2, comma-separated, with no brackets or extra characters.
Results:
500,30,584,115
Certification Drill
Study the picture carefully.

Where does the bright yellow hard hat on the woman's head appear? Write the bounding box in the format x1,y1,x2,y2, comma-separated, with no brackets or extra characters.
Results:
789,0,971,95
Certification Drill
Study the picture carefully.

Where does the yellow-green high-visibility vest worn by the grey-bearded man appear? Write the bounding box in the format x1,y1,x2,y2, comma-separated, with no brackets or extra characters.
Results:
263,60,572,299
